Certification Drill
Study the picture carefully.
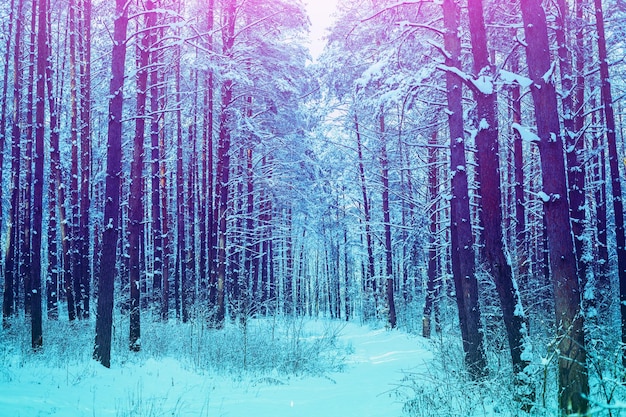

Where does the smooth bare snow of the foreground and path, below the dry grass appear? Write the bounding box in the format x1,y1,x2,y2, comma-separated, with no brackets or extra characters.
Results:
0,324,432,417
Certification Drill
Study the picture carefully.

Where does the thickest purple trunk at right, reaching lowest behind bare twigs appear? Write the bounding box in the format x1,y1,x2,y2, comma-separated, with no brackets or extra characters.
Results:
521,0,589,415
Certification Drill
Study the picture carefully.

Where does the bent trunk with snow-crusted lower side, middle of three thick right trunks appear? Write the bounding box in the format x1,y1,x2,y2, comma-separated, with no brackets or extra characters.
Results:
468,0,534,402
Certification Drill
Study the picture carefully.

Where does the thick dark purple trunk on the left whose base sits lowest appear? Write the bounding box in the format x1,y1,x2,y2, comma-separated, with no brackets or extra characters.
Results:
93,0,128,368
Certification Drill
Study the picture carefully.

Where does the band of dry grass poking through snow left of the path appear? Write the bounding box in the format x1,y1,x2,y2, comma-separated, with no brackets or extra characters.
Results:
0,317,350,381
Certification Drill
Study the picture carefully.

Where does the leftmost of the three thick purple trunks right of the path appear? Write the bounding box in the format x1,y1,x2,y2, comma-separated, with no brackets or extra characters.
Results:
442,0,487,379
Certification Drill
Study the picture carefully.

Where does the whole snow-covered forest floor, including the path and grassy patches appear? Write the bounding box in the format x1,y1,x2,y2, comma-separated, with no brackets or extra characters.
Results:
0,318,621,417
